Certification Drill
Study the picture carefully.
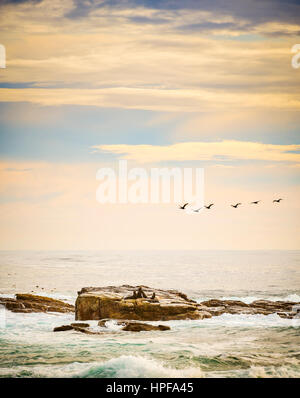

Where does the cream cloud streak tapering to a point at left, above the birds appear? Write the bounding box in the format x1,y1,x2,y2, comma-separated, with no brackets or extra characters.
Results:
93,141,300,163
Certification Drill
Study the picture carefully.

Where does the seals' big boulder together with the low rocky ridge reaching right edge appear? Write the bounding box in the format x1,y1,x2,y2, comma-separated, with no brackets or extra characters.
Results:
75,285,300,321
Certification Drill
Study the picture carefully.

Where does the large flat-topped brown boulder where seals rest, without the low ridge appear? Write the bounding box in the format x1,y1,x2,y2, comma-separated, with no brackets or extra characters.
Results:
75,285,212,321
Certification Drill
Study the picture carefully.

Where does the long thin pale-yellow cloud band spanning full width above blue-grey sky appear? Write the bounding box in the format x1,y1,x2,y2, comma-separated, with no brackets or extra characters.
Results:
0,87,300,112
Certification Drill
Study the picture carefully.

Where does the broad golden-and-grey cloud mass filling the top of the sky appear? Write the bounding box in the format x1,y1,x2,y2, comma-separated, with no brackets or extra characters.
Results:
0,0,300,112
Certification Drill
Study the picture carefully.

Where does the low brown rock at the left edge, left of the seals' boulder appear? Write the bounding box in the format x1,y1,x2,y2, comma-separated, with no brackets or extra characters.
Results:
0,294,75,313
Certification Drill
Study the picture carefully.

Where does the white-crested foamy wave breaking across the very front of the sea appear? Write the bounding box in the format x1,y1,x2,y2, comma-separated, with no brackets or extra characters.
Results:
0,355,299,379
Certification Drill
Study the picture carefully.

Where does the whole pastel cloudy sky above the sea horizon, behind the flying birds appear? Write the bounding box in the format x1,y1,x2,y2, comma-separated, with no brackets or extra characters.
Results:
0,0,300,250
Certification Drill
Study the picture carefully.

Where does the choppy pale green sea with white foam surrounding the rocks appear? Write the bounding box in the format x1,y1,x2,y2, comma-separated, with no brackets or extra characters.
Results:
0,251,300,378
